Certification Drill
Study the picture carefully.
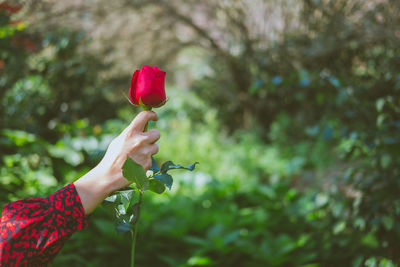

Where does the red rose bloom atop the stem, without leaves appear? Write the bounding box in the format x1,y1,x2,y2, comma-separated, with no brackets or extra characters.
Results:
129,65,166,108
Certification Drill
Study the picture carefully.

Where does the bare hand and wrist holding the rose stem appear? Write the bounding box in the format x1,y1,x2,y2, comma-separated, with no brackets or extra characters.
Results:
74,111,160,214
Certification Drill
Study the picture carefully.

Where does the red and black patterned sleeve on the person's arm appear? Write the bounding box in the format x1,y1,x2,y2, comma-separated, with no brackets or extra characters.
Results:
0,183,87,266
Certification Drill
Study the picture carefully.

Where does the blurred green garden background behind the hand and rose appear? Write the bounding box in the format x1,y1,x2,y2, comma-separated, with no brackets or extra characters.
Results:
0,0,400,267
